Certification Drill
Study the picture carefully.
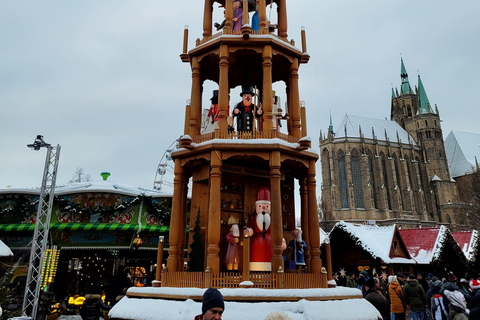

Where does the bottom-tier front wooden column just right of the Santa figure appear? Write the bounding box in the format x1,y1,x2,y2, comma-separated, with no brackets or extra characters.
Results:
270,151,283,272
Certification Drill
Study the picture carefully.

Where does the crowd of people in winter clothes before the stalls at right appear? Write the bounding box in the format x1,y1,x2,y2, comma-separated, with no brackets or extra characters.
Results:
334,270,480,320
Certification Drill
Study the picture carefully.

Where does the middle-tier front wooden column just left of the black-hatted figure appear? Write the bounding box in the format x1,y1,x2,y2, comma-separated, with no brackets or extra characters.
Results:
218,45,229,135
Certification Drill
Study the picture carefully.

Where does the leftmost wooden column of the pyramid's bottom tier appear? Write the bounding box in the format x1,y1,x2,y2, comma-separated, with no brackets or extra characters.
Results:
167,158,183,271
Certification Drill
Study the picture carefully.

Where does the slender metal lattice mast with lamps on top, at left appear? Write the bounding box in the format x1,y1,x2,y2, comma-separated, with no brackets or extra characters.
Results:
22,135,60,319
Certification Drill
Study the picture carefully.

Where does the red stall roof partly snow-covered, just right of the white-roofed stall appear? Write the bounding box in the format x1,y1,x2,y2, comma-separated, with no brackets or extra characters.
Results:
400,226,466,264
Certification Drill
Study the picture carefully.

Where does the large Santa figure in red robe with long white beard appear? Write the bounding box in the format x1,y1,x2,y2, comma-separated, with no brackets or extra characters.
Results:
250,187,272,271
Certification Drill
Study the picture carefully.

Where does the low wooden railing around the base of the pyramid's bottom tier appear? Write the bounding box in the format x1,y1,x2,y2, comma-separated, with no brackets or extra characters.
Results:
161,271,327,289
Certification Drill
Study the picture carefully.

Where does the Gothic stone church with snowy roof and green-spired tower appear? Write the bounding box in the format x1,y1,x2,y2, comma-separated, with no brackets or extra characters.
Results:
320,60,465,228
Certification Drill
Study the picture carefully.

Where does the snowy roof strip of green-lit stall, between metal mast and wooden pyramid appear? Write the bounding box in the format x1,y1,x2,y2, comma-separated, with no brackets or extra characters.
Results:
55,180,165,197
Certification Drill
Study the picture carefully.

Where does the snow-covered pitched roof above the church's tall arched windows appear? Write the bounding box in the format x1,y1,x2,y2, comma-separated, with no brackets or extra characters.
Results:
335,114,416,145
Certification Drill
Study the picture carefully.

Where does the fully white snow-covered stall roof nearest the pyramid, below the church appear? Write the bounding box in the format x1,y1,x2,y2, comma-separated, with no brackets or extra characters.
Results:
330,221,415,264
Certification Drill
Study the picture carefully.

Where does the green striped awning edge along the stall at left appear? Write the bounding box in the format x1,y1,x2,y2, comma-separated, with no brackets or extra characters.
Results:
0,223,170,233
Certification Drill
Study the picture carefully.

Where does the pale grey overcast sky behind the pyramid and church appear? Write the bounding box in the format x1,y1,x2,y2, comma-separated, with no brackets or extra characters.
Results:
0,0,480,195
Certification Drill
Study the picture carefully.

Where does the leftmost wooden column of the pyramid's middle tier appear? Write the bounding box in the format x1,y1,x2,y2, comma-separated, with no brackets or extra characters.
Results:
188,57,202,138
